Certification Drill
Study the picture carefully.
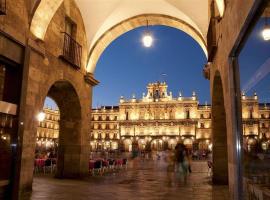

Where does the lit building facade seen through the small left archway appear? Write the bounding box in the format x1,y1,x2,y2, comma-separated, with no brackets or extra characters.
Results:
36,108,60,151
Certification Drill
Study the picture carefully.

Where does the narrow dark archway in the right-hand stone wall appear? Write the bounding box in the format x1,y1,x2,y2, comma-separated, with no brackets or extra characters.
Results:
211,71,228,184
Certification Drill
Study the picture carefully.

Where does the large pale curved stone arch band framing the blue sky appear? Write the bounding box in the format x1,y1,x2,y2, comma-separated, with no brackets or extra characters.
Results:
87,14,208,73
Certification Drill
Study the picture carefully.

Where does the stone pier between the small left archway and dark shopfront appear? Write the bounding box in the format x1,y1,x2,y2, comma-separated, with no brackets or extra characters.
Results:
12,46,41,199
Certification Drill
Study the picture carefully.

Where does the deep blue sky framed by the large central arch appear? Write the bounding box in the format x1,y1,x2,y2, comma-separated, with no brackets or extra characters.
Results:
93,26,210,107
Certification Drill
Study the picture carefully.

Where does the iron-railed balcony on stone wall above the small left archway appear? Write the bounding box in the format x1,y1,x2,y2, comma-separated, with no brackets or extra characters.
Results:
60,32,82,69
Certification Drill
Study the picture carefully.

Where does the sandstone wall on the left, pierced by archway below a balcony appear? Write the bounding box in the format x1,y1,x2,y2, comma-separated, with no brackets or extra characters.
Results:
0,0,92,198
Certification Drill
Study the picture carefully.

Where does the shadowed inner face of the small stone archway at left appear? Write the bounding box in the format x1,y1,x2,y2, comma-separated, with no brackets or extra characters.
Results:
44,80,85,178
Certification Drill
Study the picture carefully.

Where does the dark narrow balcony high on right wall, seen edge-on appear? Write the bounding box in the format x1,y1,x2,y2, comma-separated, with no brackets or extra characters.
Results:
207,1,217,62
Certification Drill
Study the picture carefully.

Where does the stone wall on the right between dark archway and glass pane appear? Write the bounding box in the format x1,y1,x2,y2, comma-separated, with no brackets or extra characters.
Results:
210,0,254,199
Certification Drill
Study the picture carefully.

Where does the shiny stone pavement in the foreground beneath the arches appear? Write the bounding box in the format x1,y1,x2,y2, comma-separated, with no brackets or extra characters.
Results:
31,161,229,200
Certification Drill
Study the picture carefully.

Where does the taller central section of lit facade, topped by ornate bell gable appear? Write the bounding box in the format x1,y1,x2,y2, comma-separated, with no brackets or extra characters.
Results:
119,82,211,151
